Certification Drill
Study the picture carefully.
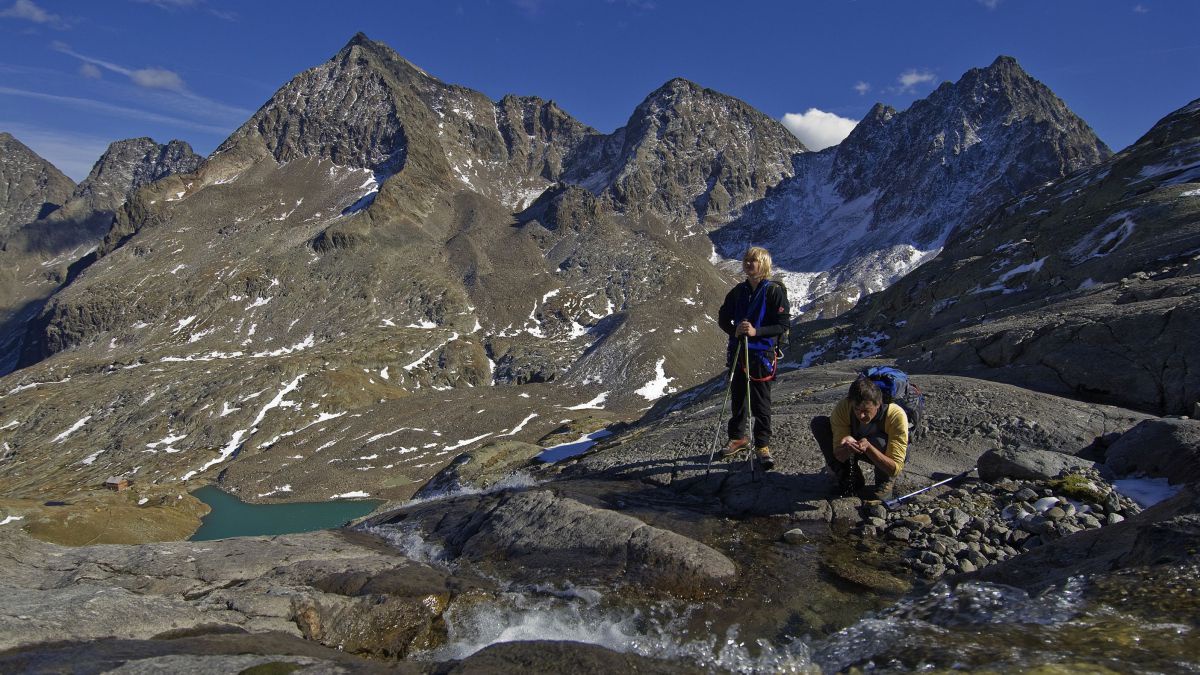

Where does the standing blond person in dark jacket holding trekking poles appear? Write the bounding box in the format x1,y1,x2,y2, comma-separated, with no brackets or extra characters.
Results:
716,246,791,470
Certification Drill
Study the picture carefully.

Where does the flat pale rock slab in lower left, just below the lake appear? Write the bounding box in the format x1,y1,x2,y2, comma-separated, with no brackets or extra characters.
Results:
0,530,458,657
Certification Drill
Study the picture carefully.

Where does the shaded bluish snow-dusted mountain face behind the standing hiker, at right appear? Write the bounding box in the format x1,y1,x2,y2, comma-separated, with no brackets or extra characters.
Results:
714,56,1110,318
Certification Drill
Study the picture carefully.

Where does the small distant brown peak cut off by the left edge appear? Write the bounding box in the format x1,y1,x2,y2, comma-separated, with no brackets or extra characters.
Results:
0,132,74,236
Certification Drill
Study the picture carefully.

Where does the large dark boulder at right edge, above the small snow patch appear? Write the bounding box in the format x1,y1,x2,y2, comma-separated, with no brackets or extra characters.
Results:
1105,419,1200,485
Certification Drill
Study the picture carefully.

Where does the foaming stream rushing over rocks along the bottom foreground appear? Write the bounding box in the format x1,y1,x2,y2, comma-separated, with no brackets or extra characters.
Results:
369,511,1200,673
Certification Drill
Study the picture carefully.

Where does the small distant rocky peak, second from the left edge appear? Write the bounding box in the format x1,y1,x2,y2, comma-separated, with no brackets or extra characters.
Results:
73,137,204,211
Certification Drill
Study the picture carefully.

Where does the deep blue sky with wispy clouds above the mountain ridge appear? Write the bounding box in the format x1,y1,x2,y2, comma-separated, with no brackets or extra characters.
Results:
0,0,1200,180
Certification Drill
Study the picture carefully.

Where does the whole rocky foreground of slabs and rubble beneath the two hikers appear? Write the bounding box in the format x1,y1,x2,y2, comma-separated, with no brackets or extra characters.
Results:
0,363,1200,673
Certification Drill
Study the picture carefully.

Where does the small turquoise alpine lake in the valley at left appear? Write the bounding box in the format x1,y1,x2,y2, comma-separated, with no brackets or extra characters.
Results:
190,485,383,542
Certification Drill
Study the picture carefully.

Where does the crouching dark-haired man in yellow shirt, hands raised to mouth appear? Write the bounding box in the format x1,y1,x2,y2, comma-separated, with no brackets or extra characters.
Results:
812,376,908,500
